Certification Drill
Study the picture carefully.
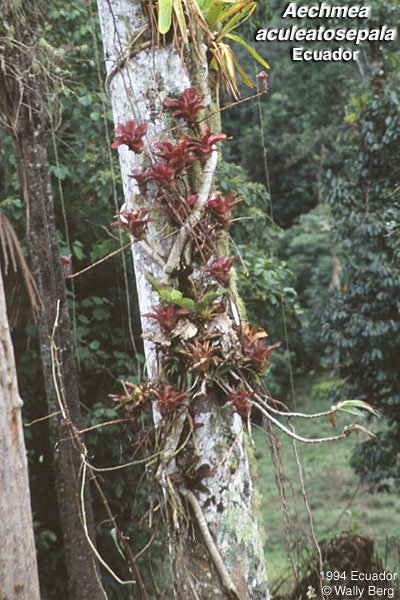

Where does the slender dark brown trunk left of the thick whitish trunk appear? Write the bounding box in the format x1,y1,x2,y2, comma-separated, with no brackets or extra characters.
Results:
0,11,104,600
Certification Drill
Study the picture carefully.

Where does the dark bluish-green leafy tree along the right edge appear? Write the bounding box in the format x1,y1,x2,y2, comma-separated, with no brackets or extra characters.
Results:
324,74,400,488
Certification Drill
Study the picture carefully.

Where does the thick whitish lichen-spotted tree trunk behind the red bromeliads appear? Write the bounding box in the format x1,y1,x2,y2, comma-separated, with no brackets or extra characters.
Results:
98,0,269,600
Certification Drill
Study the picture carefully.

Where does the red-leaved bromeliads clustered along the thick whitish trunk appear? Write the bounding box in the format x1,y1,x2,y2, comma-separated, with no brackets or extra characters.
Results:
108,90,280,454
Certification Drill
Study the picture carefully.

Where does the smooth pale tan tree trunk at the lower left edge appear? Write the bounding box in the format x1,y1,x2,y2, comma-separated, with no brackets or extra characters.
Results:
0,269,40,600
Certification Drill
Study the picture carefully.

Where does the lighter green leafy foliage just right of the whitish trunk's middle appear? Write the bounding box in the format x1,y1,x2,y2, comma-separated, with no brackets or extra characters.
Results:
218,163,301,398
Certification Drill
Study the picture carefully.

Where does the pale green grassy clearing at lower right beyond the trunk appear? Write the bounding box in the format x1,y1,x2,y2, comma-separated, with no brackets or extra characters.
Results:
253,378,400,585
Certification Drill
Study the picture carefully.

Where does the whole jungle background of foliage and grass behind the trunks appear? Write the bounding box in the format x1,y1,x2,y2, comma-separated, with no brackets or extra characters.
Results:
0,0,400,599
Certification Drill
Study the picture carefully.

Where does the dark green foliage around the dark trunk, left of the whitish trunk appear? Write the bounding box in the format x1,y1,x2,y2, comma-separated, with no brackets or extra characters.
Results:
0,0,164,600
